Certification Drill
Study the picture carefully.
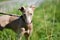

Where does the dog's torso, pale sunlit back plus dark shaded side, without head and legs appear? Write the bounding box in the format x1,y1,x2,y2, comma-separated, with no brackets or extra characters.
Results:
0,15,26,32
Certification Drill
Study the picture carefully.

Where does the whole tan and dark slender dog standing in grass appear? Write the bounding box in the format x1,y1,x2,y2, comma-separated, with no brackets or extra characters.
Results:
0,6,35,40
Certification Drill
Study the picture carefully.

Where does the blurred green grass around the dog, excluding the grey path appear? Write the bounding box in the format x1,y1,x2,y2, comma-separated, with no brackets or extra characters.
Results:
0,0,60,40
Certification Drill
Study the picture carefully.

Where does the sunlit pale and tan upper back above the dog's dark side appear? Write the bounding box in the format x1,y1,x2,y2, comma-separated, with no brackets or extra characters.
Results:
0,15,18,29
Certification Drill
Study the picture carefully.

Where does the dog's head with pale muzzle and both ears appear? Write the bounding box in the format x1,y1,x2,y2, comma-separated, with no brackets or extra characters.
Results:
19,5,35,24
